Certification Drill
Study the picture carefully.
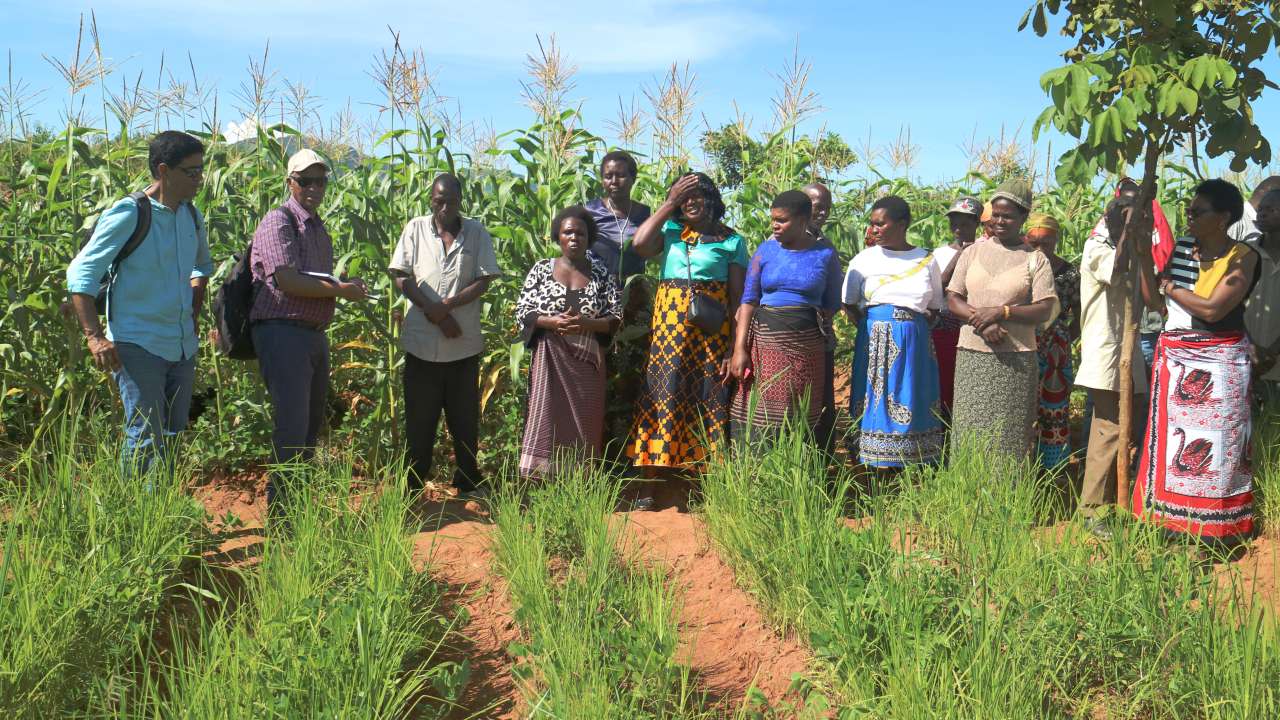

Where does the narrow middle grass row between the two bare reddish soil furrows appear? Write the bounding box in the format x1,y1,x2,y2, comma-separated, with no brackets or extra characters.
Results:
494,464,707,720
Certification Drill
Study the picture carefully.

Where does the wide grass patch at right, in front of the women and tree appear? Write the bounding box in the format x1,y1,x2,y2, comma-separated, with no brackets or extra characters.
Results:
705,422,1280,717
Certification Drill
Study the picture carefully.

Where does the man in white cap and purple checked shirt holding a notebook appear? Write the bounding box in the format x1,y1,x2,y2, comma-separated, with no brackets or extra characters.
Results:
250,150,369,518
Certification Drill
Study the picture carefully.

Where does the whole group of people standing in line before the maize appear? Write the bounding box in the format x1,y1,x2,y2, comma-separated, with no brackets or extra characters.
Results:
67,132,1280,539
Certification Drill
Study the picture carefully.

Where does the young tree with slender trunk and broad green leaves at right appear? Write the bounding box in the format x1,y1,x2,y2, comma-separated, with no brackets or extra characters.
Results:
1019,0,1280,502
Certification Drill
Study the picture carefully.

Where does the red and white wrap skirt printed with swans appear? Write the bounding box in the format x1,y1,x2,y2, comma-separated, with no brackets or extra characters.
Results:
1133,331,1253,541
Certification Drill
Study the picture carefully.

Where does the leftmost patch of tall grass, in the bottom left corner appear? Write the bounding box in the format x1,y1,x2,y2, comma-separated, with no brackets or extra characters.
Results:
0,415,205,717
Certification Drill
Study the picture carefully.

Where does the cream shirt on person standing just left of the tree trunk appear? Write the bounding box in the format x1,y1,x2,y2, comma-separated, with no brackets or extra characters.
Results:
1075,234,1147,395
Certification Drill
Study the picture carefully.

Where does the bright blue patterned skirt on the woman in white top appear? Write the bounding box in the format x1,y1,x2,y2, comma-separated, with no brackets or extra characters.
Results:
850,305,943,468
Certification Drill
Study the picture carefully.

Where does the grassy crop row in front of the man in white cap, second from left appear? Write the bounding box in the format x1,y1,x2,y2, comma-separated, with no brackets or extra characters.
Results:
110,459,465,720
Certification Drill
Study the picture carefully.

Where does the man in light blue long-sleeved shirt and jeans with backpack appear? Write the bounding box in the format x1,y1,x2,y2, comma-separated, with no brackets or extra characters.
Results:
67,131,214,473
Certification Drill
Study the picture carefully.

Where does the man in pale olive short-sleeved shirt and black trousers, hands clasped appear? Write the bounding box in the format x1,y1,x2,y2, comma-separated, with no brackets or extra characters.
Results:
389,174,502,495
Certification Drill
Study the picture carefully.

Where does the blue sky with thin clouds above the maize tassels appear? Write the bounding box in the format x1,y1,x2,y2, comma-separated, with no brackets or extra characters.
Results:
0,0,1280,181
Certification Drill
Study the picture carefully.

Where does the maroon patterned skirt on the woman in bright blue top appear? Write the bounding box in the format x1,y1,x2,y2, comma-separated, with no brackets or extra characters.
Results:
730,306,827,441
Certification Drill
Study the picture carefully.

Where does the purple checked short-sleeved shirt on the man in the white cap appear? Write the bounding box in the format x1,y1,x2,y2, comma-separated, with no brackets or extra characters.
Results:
250,196,337,327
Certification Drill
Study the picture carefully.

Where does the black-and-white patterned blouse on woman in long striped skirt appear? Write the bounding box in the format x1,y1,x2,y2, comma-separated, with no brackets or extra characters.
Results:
516,256,622,345
